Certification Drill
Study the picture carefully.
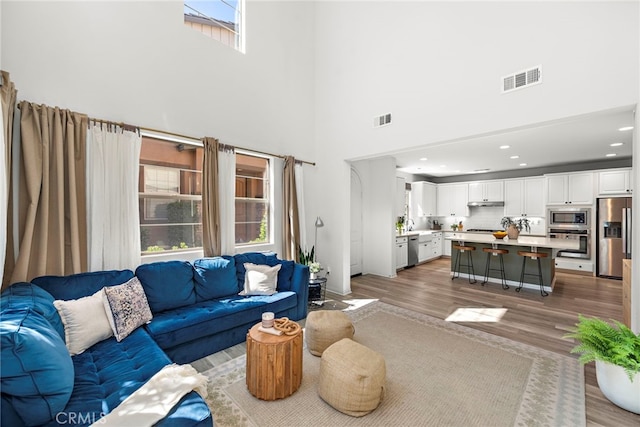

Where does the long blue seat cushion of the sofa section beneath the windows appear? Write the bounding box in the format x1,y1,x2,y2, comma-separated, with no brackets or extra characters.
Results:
146,292,297,349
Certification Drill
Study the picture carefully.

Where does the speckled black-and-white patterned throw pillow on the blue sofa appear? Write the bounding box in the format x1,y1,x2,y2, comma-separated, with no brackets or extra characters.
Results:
104,277,153,342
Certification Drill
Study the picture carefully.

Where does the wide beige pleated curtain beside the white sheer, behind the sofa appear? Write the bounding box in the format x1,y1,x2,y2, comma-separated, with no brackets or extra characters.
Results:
6,101,88,283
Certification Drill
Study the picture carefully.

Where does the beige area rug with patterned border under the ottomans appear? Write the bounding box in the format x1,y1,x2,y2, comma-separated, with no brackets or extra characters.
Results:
204,302,586,427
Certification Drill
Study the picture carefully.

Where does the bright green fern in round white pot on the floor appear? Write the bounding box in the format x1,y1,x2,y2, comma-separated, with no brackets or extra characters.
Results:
565,315,640,414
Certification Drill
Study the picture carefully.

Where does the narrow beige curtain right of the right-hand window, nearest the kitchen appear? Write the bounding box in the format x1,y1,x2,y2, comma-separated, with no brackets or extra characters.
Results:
282,156,300,261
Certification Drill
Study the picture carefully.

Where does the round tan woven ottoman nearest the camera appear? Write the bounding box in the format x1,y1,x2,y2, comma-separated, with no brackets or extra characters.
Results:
318,338,387,417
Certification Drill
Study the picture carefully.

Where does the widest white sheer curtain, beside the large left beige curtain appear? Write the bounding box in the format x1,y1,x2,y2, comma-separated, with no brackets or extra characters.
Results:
87,122,142,271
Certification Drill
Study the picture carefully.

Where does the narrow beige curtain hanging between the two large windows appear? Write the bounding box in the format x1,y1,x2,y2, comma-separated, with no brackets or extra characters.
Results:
202,138,222,257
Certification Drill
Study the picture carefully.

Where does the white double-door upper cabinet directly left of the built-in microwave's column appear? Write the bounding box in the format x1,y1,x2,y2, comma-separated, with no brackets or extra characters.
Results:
504,177,545,217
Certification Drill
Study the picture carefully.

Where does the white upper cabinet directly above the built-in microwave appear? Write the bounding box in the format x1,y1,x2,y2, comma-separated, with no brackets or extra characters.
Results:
545,172,593,205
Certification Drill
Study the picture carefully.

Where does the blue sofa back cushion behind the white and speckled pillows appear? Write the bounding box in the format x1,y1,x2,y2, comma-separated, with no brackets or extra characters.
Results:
31,270,133,300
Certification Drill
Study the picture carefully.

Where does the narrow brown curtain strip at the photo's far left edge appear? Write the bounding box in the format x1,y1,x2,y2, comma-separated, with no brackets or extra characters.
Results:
0,71,17,289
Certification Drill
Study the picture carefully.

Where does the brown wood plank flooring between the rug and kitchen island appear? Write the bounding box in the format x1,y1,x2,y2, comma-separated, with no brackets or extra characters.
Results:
342,258,640,426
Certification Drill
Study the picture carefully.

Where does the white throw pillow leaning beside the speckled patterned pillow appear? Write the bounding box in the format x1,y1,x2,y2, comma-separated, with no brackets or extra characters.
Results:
53,289,113,356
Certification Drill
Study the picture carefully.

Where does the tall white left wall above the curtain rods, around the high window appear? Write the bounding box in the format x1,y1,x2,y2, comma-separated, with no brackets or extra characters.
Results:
1,0,315,160
